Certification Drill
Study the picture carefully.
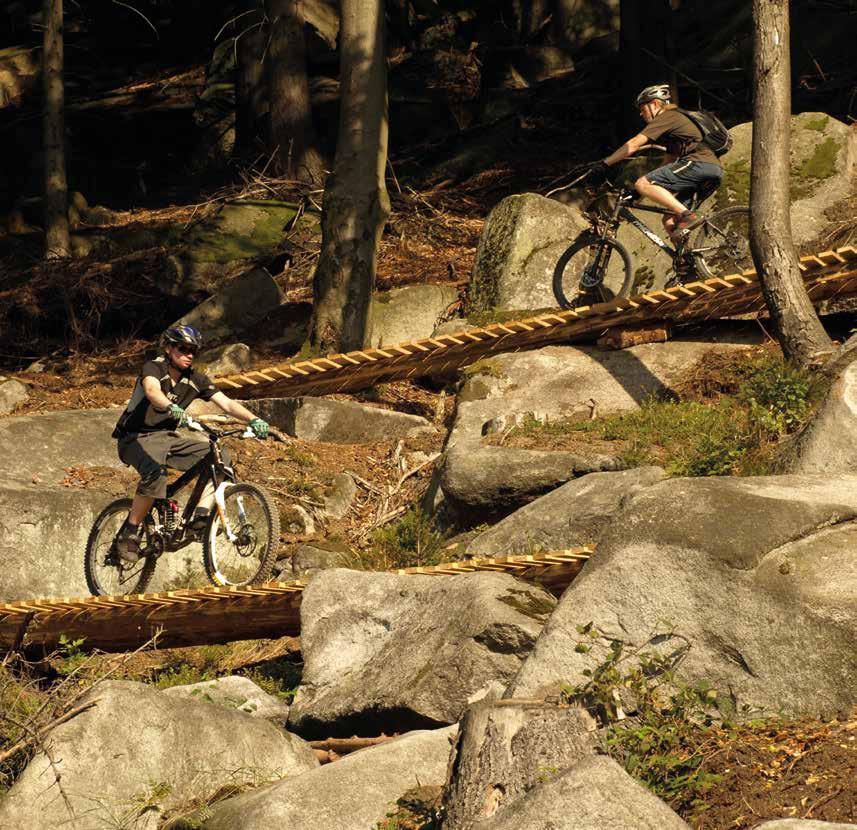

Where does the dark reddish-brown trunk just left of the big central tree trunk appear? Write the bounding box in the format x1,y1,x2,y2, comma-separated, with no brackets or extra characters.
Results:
266,0,325,184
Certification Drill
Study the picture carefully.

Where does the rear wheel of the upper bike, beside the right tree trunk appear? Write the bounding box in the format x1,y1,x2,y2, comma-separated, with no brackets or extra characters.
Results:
690,207,753,279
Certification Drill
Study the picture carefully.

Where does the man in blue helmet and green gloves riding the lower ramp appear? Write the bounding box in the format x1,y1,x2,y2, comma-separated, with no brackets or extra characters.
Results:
113,326,269,563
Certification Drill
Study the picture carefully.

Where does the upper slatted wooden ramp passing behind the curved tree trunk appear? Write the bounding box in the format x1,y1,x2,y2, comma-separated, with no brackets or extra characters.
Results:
214,247,857,399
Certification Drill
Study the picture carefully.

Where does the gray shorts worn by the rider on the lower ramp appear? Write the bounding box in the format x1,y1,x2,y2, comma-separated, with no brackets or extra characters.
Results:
118,430,229,499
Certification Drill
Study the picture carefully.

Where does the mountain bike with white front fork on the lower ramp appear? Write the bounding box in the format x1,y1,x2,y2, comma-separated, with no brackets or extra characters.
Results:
84,419,280,596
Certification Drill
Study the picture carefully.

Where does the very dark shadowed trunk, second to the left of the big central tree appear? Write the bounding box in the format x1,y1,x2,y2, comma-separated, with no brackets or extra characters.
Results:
235,0,268,158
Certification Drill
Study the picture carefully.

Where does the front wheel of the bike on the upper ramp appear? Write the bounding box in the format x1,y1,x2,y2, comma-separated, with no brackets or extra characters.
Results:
553,235,633,308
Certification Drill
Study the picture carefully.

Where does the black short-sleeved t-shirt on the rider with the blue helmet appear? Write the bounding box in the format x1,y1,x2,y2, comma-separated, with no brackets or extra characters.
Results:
113,357,218,438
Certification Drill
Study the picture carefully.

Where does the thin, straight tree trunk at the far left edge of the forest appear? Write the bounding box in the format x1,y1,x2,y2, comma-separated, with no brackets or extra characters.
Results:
42,0,71,259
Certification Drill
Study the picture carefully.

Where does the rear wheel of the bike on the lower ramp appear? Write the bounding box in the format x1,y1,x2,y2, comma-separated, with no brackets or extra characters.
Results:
83,499,157,597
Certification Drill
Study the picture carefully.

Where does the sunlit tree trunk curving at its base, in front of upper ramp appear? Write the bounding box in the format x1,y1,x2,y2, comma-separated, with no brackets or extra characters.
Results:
750,0,833,367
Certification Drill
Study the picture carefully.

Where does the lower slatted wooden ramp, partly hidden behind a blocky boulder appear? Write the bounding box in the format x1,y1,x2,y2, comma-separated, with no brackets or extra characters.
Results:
0,547,593,652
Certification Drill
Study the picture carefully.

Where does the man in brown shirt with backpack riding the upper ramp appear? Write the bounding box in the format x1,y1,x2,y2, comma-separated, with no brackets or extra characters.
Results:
595,84,723,237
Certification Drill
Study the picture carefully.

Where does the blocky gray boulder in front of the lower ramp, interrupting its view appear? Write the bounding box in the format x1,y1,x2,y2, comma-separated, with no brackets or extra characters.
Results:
289,570,556,736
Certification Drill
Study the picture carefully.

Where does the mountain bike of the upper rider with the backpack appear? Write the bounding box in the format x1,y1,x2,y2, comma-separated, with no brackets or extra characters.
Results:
553,178,753,308
